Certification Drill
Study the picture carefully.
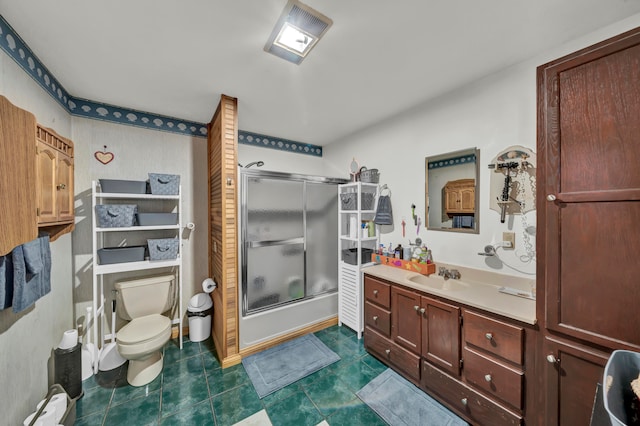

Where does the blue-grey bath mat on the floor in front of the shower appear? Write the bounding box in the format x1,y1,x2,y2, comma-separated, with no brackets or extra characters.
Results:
242,334,340,398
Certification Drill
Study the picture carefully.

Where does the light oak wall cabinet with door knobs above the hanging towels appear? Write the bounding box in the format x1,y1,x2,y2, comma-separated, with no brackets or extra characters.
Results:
35,125,74,240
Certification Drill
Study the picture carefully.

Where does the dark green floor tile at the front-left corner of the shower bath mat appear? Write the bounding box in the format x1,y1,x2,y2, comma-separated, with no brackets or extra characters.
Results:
211,383,264,426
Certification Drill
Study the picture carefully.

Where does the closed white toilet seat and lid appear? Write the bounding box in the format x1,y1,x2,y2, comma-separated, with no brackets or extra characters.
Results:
116,314,171,359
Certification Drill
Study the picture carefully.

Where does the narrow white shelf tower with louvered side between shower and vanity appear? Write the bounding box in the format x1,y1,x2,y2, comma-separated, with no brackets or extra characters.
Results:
338,182,380,339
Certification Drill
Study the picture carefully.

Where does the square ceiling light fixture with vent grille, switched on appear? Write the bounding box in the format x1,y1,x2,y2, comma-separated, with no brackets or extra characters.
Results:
264,0,333,65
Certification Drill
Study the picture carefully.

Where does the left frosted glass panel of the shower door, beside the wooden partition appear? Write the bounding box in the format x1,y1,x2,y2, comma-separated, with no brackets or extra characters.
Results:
242,176,305,314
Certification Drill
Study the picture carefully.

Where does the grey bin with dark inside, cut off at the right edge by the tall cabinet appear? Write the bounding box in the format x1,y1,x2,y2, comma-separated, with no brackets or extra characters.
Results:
603,350,640,426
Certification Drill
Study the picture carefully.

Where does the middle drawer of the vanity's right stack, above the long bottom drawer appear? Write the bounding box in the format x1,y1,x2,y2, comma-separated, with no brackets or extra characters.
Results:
462,348,524,410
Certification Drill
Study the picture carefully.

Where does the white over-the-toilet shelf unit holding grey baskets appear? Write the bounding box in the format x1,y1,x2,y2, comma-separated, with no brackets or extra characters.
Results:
91,181,183,362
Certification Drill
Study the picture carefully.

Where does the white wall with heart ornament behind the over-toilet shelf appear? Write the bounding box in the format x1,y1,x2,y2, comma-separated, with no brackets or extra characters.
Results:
72,117,208,333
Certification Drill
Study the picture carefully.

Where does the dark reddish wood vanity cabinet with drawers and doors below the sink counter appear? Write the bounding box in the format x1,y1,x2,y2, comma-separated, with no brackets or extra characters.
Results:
364,274,537,426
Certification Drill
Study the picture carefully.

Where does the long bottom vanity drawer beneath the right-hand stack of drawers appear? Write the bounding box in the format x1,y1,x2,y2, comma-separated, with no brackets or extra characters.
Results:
422,361,522,426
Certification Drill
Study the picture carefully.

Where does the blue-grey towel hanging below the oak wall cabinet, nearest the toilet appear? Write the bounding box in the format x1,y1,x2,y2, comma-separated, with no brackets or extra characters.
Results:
11,235,51,313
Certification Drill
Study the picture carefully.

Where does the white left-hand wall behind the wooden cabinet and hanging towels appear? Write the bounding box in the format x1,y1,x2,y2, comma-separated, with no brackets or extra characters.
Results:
0,53,74,425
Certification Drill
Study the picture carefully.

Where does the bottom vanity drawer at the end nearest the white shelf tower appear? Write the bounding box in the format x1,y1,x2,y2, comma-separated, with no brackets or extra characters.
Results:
364,327,420,384
